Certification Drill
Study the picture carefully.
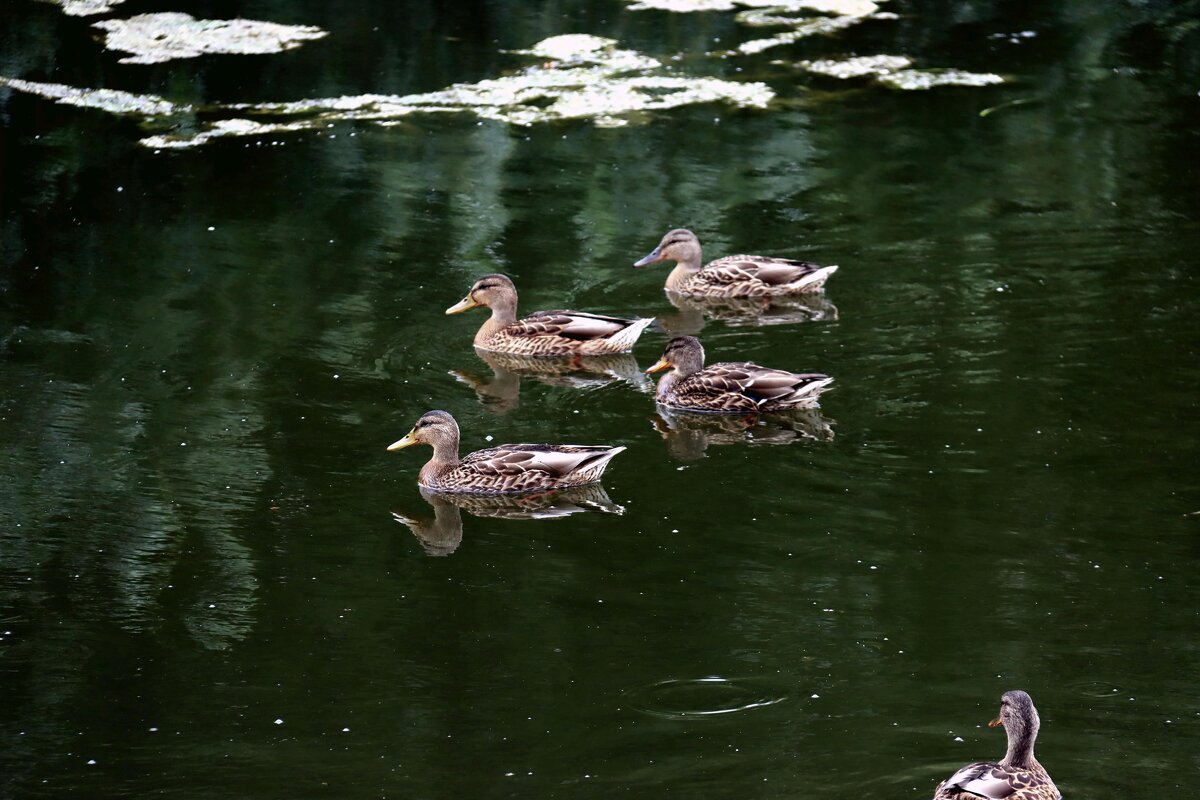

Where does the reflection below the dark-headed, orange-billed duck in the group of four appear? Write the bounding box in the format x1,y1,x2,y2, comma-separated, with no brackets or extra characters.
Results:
650,405,834,461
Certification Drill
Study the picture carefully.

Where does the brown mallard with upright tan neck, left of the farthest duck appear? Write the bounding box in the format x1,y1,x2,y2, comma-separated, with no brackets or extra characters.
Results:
446,273,654,356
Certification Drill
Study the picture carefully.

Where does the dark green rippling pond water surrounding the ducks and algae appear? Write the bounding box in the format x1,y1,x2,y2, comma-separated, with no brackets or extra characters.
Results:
0,0,1200,799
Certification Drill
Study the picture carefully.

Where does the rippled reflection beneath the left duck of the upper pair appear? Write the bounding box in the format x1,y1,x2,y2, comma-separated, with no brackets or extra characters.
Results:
450,348,653,414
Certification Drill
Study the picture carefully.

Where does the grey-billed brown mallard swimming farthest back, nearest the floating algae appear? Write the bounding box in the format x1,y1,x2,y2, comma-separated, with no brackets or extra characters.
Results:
634,228,838,297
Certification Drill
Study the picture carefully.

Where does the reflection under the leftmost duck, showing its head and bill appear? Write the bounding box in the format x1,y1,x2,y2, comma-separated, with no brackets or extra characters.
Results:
391,483,625,555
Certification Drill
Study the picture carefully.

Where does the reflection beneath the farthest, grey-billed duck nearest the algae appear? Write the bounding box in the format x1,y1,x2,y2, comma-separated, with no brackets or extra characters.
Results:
658,290,838,336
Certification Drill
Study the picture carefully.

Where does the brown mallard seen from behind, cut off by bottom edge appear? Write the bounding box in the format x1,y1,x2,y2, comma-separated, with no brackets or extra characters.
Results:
934,690,1062,800
